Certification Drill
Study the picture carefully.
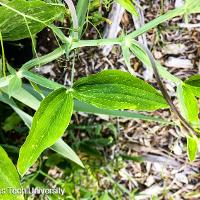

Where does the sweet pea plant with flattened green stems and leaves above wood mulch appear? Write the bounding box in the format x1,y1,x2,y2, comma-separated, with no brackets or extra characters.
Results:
0,0,200,199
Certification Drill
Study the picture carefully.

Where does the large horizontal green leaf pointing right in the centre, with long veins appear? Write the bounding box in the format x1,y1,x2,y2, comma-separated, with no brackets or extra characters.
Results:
73,70,168,110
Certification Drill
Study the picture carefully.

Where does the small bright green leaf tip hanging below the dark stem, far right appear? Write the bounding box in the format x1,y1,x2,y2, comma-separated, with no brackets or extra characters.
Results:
187,136,199,161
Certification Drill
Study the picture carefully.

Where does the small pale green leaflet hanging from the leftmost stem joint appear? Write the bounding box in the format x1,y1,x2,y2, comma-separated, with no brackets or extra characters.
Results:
8,75,22,96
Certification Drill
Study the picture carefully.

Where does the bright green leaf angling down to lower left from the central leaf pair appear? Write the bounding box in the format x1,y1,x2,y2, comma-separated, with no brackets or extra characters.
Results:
17,88,73,175
